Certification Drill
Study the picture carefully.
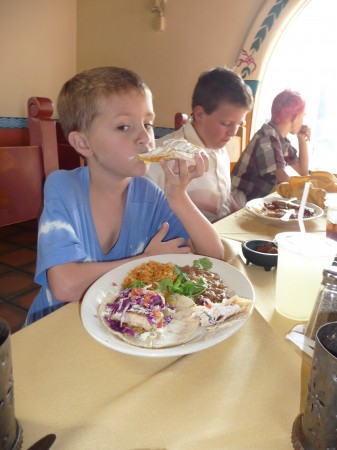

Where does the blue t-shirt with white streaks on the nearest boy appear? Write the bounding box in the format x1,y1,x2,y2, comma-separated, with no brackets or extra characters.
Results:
26,167,188,325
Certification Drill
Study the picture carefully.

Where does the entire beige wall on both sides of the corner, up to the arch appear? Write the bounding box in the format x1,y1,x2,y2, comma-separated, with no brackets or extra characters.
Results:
0,0,265,121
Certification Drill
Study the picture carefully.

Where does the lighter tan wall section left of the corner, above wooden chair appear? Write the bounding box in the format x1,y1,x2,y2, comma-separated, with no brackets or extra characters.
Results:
0,0,76,117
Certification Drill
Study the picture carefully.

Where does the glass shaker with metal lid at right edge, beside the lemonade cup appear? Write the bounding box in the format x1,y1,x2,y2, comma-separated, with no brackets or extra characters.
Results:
305,266,337,340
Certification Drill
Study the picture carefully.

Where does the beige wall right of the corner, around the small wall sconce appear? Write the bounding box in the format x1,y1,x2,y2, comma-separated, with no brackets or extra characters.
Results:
77,0,265,127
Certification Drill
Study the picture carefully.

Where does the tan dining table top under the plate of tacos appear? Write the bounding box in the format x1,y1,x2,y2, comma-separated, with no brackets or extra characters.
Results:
11,203,324,450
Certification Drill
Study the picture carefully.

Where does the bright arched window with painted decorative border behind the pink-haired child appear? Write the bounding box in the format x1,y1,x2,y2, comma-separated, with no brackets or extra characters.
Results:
237,0,337,173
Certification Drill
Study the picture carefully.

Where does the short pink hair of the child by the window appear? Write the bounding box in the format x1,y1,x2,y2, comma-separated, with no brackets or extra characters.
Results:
271,89,305,124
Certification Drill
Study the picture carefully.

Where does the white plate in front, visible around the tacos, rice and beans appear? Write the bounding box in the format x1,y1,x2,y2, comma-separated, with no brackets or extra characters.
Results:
81,254,255,357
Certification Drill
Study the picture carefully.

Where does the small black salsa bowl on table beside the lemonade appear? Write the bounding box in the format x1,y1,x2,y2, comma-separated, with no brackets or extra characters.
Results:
242,239,277,272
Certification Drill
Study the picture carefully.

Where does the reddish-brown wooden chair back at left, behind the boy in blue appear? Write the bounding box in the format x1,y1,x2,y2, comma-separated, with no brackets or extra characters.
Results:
0,97,59,226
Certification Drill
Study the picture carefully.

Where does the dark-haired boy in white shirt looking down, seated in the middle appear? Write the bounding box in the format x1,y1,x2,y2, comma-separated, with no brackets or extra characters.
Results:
148,68,253,222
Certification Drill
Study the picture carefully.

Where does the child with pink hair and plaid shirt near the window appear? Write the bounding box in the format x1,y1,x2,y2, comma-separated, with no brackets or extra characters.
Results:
231,89,310,202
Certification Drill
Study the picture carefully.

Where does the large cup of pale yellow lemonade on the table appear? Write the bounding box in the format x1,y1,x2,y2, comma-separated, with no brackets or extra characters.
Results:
275,232,337,321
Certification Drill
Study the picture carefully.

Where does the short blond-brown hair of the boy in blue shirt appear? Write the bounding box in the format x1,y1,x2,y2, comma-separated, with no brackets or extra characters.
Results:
57,67,149,138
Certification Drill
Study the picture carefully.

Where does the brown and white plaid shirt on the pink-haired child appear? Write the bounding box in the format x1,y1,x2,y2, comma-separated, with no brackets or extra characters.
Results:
231,122,297,200
